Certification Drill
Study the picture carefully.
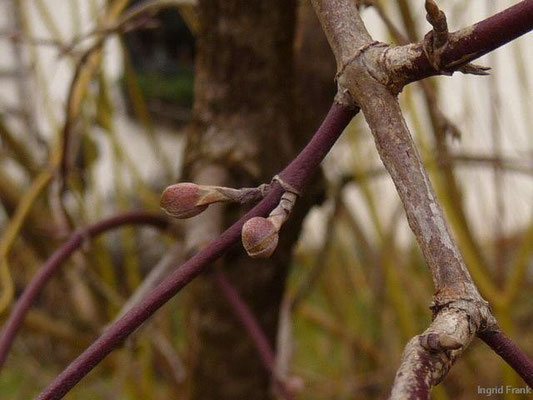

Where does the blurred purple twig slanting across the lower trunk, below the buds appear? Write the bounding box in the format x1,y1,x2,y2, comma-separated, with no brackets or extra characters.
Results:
213,268,294,400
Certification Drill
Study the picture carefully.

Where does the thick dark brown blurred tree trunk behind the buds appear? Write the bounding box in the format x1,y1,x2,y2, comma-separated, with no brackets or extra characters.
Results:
183,0,333,400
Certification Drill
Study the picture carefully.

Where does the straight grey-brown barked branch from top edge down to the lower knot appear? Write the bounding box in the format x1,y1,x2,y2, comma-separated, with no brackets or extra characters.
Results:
313,0,481,300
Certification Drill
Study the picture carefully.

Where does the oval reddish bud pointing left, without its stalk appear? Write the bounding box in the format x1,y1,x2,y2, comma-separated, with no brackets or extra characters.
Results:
159,182,207,218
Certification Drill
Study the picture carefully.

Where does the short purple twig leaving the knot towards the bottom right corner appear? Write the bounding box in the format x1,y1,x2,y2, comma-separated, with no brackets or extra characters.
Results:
478,329,533,388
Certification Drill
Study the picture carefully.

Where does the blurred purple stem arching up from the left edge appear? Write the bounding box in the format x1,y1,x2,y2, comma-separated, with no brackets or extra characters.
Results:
0,212,168,368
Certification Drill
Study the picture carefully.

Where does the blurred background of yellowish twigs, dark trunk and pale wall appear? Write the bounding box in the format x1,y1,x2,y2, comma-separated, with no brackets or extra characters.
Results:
0,0,533,400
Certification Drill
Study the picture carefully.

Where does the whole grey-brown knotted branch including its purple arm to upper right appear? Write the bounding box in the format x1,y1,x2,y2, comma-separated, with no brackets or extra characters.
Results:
313,0,533,399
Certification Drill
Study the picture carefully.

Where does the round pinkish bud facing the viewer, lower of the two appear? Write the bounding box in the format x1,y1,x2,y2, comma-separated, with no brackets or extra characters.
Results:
242,217,279,258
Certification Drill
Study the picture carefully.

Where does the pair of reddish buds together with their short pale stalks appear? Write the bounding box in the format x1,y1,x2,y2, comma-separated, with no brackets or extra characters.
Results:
160,179,298,258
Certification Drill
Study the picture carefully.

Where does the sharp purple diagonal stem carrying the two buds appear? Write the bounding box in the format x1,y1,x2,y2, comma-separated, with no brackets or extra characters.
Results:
34,104,359,400
